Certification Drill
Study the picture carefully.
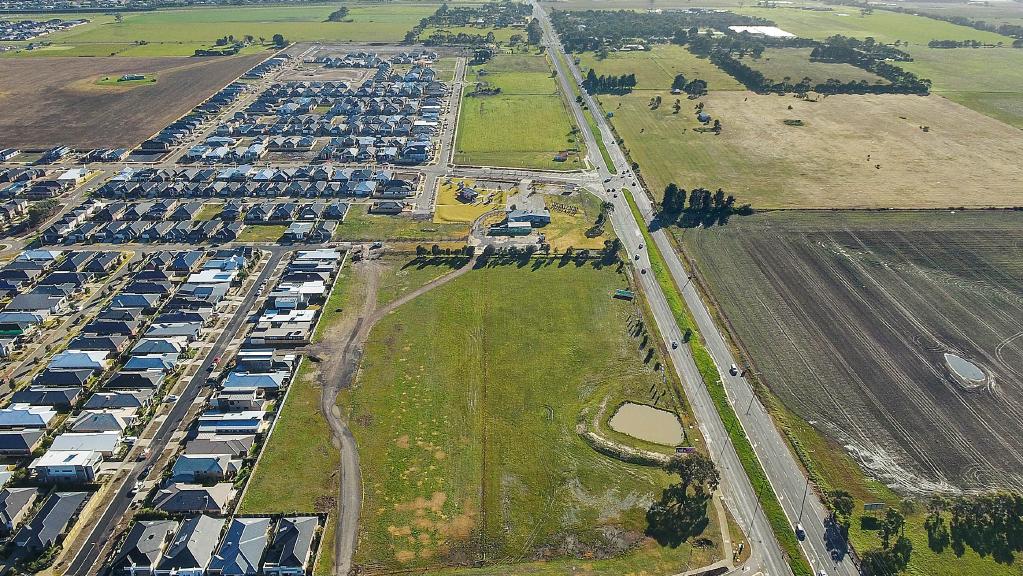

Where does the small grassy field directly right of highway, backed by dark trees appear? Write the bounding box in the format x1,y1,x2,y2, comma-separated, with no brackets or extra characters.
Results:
581,44,743,90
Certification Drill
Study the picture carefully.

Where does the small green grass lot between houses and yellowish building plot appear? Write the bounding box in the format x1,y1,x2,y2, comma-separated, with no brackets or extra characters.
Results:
343,204,469,241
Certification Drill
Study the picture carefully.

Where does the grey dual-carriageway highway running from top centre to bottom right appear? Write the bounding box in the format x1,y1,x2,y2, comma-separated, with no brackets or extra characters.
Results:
534,2,858,576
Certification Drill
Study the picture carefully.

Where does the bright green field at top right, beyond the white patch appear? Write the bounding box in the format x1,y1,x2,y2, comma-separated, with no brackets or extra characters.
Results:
732,6,1013,46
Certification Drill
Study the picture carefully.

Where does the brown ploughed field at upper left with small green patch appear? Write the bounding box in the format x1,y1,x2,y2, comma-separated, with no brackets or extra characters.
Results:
0,52,269,148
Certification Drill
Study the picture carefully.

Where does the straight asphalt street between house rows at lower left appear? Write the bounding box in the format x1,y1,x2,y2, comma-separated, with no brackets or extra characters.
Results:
64,251,285,576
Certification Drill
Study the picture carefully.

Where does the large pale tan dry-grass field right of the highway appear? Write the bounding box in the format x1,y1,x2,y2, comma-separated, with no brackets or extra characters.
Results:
603,92,1023,208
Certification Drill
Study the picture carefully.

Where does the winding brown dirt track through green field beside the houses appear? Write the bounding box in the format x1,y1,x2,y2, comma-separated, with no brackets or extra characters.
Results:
309,256,476,576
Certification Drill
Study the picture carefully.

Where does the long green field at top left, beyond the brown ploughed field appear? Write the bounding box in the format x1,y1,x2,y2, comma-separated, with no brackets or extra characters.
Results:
3,3,437,55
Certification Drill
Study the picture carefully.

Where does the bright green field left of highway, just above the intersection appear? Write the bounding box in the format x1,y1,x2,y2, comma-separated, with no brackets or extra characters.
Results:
454,54,583,170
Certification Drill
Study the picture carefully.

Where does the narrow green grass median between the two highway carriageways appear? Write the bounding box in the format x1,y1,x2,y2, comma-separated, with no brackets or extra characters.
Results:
622,189,813,576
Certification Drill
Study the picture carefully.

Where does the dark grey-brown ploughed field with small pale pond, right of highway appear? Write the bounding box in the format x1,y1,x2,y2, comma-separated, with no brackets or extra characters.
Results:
680,211,1023,493
